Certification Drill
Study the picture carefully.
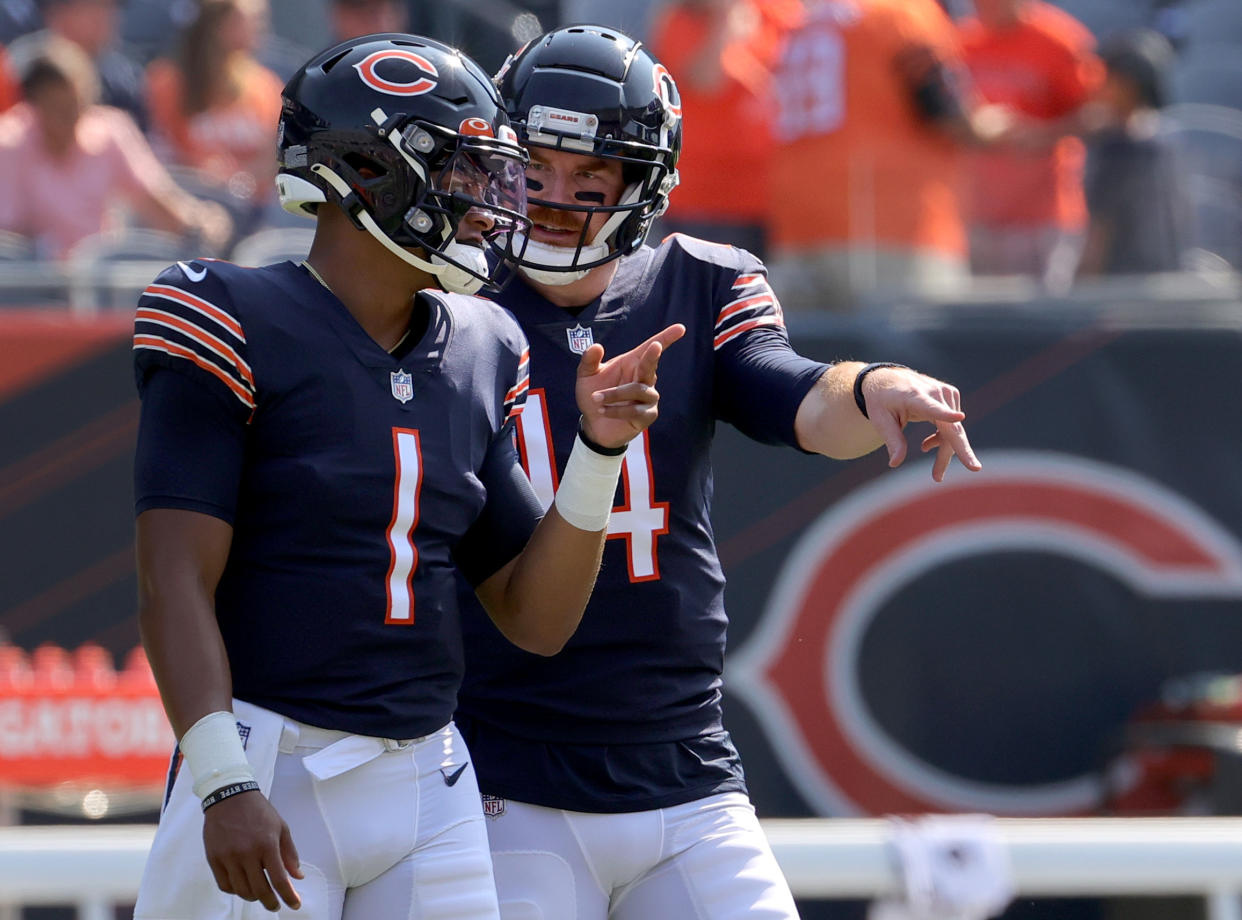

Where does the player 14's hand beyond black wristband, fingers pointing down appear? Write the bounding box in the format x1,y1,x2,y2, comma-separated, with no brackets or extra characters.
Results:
862,366,982,482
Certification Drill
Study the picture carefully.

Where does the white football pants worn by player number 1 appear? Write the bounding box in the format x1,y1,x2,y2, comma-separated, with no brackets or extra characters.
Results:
134,701,498,920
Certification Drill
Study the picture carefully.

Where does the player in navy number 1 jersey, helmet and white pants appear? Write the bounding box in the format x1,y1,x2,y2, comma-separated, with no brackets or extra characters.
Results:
134,34,682,920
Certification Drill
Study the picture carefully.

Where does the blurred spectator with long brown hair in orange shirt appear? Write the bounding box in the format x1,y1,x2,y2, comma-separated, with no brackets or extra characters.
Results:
147,0,283,233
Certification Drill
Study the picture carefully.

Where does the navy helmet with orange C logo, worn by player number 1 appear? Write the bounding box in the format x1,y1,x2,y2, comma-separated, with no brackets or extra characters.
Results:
276,34,529,294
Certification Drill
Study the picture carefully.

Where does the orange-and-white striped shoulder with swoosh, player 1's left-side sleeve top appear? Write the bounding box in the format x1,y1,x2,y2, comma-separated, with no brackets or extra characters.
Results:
134,259,255,410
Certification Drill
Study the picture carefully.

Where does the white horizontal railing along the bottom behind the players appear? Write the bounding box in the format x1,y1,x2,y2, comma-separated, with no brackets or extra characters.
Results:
7,818,1242,920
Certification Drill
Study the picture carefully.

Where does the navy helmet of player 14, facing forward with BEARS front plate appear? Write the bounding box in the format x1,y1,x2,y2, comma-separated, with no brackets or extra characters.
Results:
496,25,682,284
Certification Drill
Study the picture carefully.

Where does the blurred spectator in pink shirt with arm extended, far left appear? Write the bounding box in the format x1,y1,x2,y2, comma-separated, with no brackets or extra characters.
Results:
0,36,230,258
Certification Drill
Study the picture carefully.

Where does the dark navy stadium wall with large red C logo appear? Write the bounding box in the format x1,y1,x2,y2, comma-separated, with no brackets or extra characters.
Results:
0,303,1242,817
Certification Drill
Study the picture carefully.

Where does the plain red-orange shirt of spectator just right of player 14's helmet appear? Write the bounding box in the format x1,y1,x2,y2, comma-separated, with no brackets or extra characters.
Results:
652,0,801,222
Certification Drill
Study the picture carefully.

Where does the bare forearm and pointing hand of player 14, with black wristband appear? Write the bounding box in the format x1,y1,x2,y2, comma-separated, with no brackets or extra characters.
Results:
794,361,982,482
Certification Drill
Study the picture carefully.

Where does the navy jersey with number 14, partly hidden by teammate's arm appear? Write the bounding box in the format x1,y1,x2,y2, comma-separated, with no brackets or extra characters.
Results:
457,235,826,812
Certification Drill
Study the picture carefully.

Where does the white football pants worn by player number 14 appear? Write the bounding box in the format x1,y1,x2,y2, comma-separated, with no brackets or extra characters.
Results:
487,792,797,920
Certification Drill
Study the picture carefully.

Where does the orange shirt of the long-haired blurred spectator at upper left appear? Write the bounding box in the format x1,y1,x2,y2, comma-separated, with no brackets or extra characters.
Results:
147,58,283,199
